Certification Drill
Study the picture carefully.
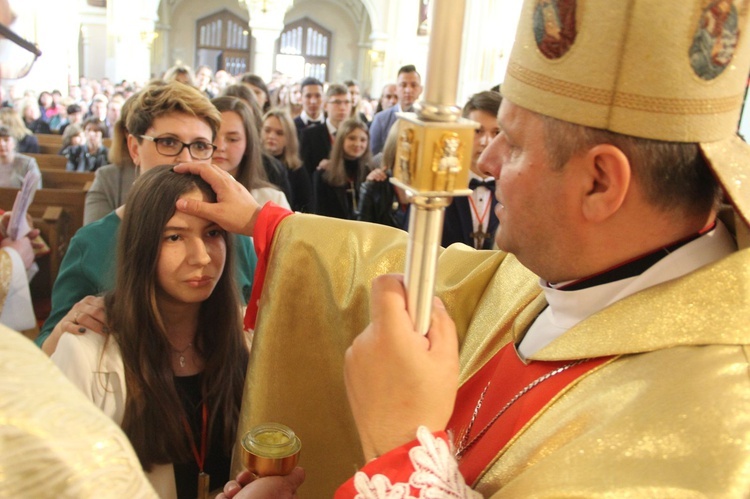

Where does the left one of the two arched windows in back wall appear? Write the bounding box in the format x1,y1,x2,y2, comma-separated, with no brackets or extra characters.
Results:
195,9,250,75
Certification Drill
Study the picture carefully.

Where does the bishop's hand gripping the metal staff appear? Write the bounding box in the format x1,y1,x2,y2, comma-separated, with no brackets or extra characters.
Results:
344,275,458,460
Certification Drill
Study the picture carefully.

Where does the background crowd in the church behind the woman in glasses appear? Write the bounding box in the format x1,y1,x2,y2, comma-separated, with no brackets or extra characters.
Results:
0,65,476,231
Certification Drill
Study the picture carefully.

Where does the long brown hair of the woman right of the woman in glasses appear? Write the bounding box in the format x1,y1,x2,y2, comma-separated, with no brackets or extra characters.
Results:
211,96,273,190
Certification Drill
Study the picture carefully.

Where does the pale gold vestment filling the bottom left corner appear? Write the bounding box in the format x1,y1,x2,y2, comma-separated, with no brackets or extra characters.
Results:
0,325,158,499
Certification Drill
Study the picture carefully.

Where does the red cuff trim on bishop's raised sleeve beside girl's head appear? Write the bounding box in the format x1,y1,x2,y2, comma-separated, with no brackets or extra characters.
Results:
245,201,292,329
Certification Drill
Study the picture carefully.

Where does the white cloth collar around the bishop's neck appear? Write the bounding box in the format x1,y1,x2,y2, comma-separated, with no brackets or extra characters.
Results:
518,220,737,358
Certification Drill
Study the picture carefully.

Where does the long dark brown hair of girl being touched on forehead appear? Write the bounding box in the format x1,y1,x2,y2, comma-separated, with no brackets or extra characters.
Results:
106,165,248,471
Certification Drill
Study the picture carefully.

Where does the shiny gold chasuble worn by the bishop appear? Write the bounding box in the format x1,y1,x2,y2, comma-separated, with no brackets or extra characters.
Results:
234,214,750,498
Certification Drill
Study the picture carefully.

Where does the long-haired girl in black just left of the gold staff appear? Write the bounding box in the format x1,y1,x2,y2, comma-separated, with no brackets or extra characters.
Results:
313,118,371,220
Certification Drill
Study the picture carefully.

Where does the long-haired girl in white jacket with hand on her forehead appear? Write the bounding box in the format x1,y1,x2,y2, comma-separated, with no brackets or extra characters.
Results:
52,165,248,498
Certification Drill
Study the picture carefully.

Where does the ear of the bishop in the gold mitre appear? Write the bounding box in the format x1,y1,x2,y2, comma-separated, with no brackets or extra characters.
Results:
583,144,632,222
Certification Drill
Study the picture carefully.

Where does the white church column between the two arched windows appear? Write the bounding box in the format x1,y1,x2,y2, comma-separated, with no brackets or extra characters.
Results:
246,0,293,81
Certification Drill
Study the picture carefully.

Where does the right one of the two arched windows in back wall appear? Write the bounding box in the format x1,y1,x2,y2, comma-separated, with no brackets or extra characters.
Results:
276,17,331,81
